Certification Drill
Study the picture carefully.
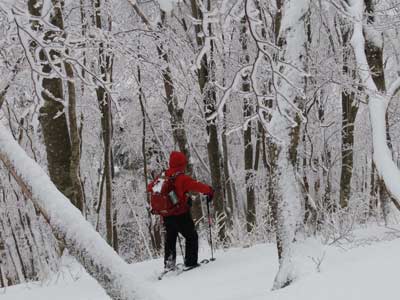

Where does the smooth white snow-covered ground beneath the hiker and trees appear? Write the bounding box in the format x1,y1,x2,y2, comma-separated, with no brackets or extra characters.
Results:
0,227,400,300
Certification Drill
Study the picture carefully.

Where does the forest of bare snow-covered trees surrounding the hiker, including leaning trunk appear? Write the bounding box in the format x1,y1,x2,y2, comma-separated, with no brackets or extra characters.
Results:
0,0,400,299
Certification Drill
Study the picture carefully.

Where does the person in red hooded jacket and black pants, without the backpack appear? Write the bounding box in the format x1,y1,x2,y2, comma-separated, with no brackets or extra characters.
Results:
148,151,214,270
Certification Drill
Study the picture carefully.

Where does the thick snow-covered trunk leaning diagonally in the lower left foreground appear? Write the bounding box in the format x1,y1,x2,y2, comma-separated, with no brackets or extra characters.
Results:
0,124,159,300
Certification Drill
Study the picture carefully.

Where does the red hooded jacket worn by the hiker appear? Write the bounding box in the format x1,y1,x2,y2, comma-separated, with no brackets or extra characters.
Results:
147,151,213,215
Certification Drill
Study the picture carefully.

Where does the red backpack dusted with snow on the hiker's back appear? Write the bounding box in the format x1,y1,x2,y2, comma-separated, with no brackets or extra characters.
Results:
150,173,181,217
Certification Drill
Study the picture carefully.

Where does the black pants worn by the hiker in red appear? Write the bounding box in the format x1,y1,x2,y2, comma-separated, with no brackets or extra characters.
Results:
164,212,199,268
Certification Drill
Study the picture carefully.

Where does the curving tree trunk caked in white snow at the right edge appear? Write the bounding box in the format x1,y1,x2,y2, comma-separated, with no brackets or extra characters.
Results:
347,0,400,212
